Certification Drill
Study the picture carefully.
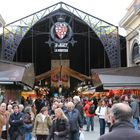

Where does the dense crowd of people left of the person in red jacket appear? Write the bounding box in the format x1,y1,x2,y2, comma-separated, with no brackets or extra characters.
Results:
0,96,83,140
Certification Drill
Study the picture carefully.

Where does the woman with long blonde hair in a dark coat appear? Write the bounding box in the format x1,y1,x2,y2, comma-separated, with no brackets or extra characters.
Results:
47,108,70,140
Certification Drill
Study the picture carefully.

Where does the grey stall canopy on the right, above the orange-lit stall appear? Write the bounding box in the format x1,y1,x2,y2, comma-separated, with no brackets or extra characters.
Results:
91,66,140,90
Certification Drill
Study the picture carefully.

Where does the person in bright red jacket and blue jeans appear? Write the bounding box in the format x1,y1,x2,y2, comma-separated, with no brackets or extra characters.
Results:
84,99,95,131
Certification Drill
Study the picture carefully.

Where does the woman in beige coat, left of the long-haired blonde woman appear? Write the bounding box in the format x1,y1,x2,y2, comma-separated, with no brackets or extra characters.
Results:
33,107,52,140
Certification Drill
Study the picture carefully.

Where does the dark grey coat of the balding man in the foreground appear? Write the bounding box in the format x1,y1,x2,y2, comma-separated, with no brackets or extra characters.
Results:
98,121,140,140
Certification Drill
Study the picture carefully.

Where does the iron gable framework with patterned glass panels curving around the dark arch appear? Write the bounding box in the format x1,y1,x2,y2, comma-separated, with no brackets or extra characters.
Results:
1,2,120,67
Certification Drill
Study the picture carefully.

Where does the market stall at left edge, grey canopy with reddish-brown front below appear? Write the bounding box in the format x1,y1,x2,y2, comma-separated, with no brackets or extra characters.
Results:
0,60,35,102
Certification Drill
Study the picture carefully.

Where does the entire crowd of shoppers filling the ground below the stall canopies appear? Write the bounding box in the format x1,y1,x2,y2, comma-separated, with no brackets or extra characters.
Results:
0,92,139,140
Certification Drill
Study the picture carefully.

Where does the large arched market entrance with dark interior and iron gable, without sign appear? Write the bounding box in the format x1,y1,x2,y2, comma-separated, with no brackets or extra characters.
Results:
2,2,120,90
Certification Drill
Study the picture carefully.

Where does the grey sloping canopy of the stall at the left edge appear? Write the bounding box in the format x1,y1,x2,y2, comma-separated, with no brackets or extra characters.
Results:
0,60,35,87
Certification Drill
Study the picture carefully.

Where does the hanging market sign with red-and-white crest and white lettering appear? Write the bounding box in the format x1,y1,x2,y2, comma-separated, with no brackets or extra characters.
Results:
47,17,76,53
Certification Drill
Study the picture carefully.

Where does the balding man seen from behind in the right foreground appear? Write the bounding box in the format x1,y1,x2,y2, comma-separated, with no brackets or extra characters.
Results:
98,103,140,140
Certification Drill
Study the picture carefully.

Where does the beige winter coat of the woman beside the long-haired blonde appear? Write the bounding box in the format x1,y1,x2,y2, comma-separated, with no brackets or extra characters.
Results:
33,113,52,135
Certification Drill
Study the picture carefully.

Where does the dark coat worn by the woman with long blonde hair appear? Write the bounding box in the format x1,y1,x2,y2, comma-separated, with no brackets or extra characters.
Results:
47,119,70,140
